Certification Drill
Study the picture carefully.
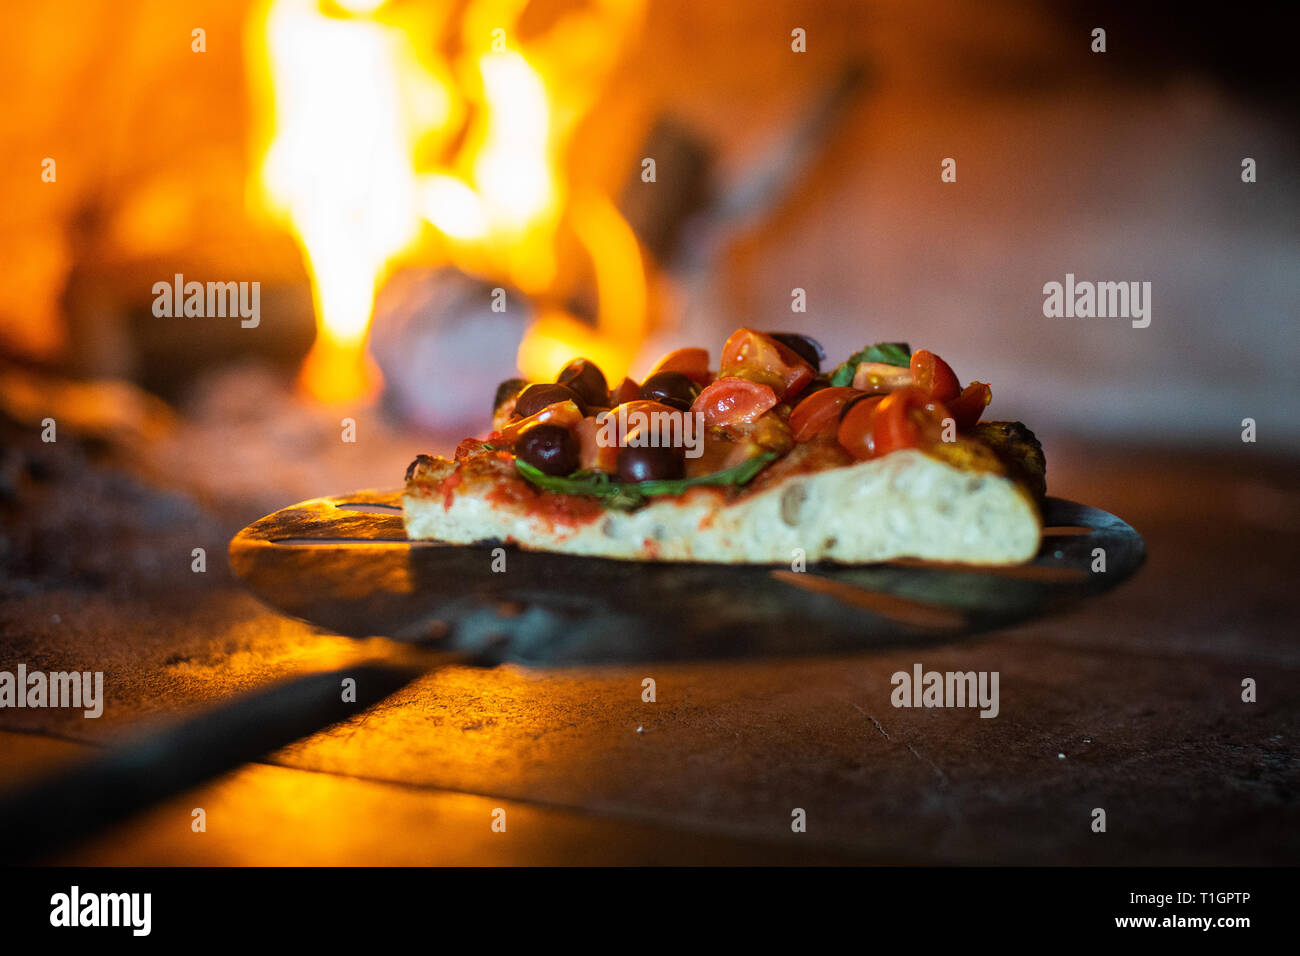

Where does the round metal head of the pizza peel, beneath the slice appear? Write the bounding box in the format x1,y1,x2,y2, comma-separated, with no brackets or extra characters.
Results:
230,490,1144,665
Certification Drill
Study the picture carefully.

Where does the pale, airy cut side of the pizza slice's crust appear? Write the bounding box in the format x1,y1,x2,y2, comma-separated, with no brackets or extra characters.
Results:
403,450,1041,564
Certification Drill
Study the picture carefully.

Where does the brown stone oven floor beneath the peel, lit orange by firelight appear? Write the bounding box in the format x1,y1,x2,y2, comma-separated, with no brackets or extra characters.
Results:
0,441,1300,865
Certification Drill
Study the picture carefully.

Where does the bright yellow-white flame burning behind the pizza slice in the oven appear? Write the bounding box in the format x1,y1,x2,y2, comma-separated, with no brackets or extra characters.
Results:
250,0,645,402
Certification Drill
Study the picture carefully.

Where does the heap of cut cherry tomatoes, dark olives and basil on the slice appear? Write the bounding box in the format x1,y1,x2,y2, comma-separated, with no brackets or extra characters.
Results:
436,329,992,507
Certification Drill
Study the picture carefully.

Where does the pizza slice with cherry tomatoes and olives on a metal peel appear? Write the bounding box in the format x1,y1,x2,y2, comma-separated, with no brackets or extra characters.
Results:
403,329,1045,564
